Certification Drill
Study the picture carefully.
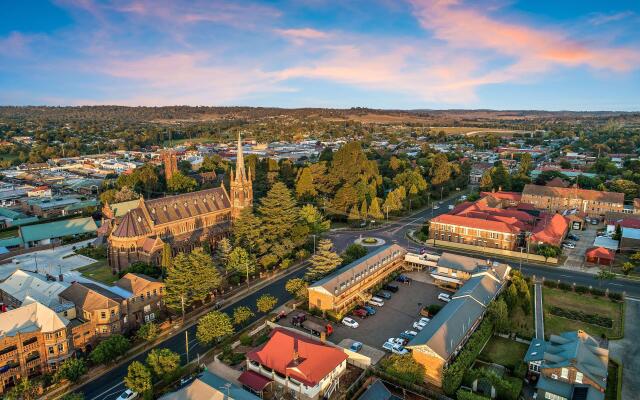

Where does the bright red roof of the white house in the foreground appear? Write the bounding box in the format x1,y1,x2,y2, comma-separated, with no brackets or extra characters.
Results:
247,329,348,386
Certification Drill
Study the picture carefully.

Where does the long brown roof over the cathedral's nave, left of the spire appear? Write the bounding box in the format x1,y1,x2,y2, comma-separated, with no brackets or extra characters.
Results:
144,187,231,224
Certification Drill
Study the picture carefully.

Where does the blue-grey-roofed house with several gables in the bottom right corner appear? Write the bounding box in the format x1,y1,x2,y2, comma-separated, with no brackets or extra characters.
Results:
524,331,609,400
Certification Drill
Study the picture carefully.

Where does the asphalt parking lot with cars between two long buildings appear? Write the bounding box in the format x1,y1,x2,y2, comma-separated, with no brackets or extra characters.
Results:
329,278,445,349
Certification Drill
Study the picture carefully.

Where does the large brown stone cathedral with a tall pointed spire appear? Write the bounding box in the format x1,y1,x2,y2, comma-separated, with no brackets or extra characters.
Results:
105,135,253,273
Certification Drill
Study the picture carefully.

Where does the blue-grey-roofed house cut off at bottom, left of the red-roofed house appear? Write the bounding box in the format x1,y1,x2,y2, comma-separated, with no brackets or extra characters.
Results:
161,371,260,400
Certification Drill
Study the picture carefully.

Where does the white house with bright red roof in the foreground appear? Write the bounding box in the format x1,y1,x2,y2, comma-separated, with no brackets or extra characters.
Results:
240,328,348,400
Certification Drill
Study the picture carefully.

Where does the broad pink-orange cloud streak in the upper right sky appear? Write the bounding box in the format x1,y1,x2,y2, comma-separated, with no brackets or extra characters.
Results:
410,0,640,72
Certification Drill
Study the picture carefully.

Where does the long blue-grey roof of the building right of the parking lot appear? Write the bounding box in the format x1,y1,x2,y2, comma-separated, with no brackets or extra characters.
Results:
407,271,504,360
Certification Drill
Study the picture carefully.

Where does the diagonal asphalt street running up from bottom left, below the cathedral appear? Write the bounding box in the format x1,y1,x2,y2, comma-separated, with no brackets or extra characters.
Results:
77,268,306,400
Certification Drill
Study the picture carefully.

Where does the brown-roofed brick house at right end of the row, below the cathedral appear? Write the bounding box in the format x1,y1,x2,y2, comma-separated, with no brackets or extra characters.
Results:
115,273,165,329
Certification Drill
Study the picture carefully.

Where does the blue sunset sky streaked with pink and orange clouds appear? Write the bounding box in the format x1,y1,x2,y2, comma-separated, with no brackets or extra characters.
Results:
0,0,640,111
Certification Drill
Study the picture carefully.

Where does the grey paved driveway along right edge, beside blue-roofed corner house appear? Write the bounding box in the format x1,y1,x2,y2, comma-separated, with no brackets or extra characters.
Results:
609,298,640,399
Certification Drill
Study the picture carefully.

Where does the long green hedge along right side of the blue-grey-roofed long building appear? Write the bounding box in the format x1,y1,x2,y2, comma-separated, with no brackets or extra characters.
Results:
442,319,493,396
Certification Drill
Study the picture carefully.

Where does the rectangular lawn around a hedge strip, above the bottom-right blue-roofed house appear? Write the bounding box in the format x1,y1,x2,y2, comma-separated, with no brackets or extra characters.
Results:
542,287,624,337
